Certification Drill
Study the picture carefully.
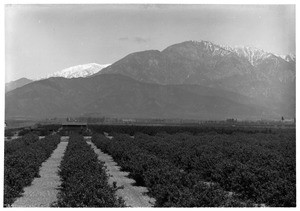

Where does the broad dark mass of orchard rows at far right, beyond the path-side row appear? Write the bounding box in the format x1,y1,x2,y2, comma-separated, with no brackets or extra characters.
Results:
131,133,296,207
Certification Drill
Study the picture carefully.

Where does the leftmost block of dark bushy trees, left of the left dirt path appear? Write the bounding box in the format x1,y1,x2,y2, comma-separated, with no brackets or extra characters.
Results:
4,134,60,207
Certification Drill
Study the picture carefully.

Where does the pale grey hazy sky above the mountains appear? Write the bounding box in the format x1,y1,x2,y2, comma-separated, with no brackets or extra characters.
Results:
5,5,295,82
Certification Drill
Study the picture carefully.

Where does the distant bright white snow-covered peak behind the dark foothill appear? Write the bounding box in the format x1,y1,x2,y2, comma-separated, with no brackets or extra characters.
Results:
46,63,109,78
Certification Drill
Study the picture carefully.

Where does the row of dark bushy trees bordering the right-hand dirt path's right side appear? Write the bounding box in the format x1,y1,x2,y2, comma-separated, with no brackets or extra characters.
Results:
92,135,251,207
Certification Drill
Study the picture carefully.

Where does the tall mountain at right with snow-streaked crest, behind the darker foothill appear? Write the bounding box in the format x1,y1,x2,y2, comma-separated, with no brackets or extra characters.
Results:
95,41,296,118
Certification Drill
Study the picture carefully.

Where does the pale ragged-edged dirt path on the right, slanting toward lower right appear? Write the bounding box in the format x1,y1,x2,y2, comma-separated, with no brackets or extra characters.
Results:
86,139,155,207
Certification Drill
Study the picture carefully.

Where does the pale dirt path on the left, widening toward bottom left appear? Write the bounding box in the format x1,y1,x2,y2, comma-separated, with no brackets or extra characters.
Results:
12,137,68,207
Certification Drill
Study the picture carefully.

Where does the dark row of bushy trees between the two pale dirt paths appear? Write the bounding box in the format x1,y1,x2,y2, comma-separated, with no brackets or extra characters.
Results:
53,134,124,207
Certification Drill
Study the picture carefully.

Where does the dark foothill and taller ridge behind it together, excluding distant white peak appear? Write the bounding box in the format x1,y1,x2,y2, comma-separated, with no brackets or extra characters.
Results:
5,41,296,120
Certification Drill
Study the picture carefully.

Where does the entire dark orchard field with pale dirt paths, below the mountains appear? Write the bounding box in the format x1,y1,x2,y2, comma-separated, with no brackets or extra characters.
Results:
4,125,296,207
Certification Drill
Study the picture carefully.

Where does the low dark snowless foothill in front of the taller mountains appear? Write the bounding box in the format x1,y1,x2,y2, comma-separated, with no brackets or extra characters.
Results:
5,74,277,119
